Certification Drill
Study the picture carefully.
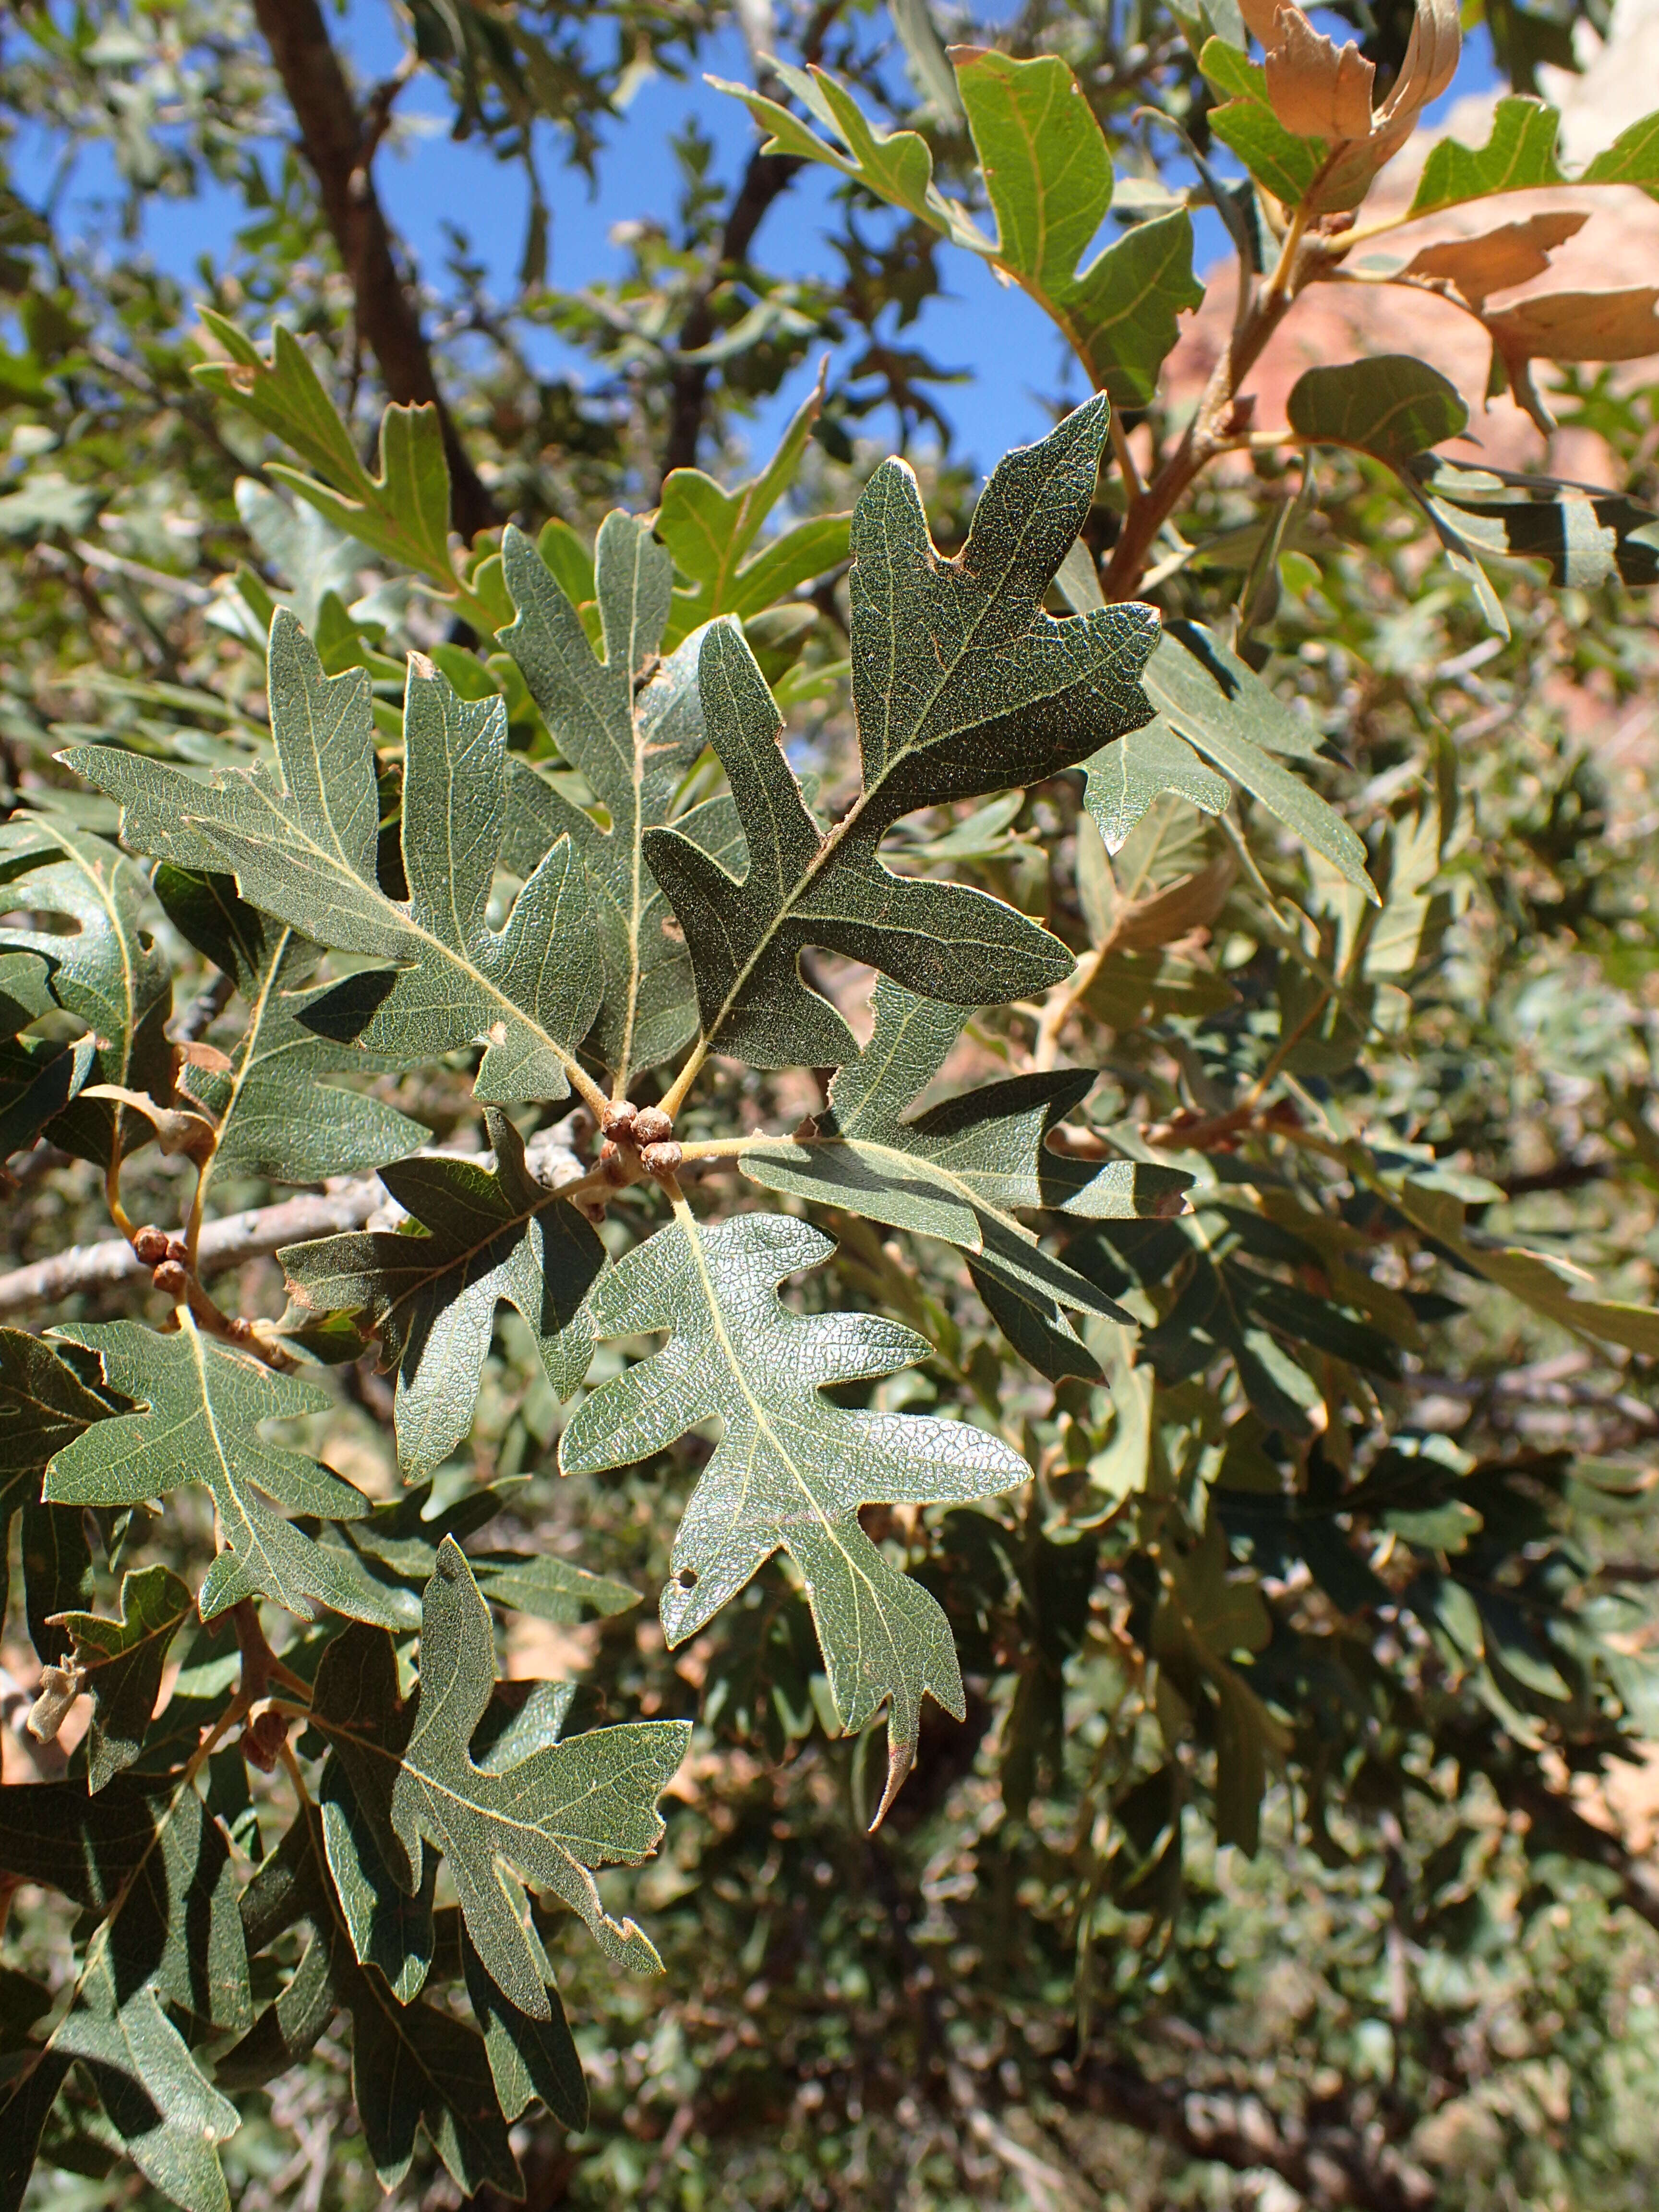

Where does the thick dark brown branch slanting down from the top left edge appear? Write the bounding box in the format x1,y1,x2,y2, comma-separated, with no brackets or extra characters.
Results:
254,0,502,544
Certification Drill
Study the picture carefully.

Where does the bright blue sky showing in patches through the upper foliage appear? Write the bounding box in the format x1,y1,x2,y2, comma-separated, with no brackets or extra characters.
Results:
13,0,1493,469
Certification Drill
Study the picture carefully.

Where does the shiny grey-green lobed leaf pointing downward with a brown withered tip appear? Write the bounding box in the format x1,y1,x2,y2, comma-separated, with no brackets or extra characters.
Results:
560,1203,1026,1818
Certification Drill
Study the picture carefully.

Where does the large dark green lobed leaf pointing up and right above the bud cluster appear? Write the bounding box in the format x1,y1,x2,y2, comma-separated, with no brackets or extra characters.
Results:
644,400,1157,1066
